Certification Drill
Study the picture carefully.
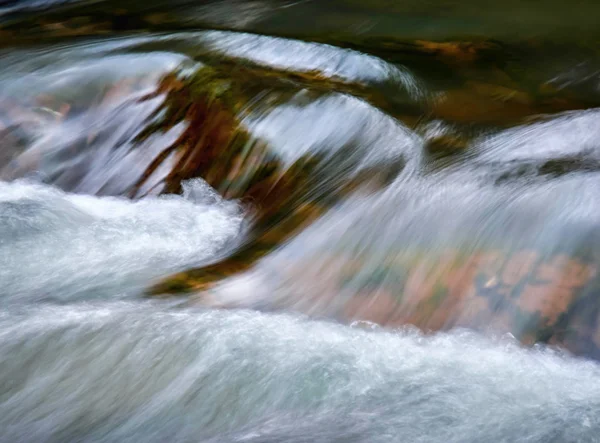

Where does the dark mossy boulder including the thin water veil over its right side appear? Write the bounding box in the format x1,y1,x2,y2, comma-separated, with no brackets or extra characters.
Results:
146,62,417,294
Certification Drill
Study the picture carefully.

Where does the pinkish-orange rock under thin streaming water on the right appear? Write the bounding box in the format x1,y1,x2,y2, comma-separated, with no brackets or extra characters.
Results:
199,245,600,356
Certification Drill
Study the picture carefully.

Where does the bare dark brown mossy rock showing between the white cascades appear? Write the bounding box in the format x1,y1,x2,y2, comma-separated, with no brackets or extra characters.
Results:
144,65,403,295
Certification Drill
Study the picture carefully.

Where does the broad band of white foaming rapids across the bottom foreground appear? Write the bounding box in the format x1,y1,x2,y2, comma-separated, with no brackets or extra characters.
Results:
0,302,600,443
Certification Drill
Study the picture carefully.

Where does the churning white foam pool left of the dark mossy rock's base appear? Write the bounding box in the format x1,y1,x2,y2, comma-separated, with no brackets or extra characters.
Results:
0,180,243,300
